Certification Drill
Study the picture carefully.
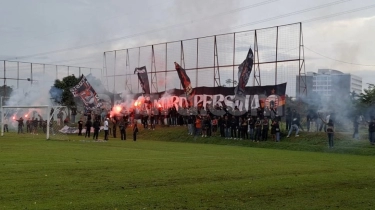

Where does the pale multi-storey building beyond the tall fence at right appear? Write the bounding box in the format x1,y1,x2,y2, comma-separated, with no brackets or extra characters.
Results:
296,69,362,102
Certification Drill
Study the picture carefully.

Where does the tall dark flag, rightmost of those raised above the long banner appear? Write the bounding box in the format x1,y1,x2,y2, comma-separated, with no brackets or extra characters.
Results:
234,48,254,101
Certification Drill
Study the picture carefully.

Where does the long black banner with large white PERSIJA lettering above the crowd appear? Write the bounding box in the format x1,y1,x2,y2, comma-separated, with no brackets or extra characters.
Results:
134,83,286,116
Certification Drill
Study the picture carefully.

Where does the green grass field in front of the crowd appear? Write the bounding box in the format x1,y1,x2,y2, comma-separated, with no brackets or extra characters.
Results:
0,127,375,209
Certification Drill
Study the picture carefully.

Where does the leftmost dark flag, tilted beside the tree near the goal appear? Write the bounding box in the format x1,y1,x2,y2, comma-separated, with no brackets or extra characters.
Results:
70,75,102,110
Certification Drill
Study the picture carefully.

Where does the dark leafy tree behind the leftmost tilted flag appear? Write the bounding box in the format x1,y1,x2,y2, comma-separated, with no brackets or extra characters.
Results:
54,75,79,108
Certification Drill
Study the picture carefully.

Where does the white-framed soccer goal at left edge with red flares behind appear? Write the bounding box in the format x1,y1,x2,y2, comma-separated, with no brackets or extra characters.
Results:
1,105,69,140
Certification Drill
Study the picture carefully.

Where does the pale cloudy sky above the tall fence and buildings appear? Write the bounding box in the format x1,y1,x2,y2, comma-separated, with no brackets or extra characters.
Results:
0,0,375,93
